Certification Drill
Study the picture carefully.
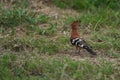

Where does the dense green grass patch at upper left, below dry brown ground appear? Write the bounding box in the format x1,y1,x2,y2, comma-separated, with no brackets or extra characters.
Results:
0,9,50,34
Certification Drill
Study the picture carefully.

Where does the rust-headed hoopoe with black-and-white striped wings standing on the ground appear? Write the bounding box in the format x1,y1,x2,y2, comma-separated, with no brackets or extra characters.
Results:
70,21,96,55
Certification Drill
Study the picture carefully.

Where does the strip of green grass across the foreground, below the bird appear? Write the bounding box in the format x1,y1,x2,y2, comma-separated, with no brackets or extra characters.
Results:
0,53,119,80
